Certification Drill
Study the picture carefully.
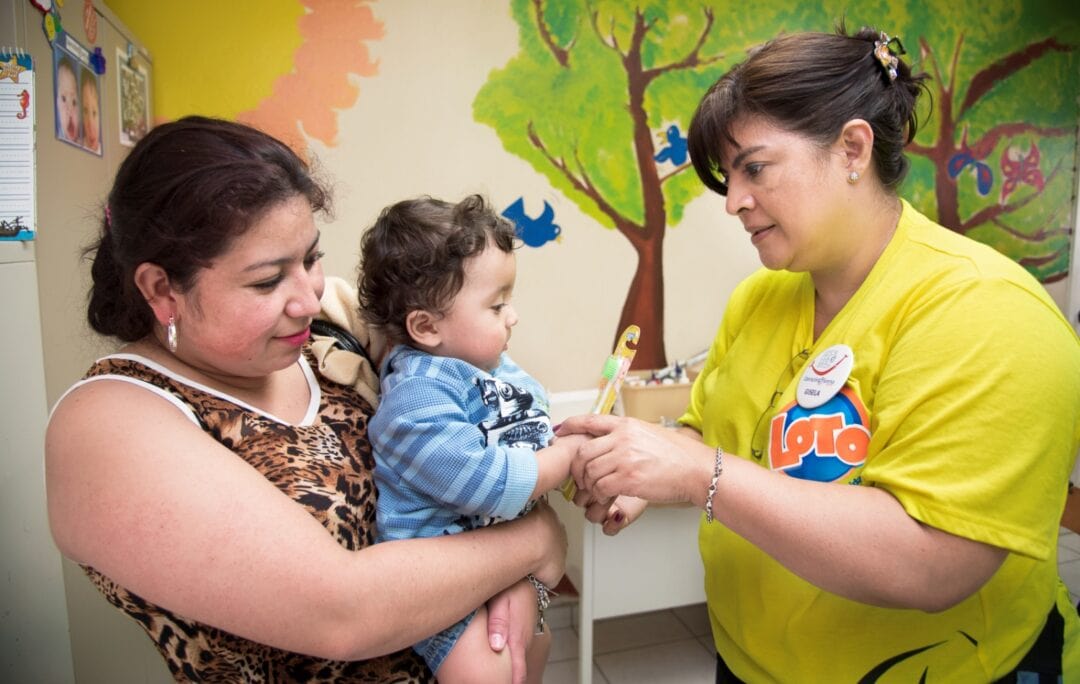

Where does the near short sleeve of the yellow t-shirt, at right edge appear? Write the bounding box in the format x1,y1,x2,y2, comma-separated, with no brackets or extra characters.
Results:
863,280,1080,560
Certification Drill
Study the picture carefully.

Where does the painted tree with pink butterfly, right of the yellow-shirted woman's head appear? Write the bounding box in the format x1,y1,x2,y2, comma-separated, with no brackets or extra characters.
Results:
903,1,1080,283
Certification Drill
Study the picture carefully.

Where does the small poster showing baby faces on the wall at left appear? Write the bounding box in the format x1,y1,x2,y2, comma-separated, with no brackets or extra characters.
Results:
53,33,102,157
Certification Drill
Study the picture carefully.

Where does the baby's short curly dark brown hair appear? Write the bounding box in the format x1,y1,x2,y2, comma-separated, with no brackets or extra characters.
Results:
356,195,517,345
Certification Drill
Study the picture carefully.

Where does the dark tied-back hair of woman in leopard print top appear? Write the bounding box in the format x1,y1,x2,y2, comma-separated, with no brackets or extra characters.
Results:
84,117,329,341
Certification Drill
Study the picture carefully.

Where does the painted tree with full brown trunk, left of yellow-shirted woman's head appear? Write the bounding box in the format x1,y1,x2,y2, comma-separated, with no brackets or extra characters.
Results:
474,0,825,367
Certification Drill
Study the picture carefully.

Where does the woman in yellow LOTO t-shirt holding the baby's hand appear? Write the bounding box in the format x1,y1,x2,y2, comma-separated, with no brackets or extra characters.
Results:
559,27,1080,682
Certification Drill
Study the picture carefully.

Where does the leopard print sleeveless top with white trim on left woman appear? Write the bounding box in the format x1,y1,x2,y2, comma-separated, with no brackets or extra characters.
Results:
83,354,434,683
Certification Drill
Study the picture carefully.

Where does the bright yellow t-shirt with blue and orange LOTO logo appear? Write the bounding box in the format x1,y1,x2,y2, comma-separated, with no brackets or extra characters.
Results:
680,202,1080,682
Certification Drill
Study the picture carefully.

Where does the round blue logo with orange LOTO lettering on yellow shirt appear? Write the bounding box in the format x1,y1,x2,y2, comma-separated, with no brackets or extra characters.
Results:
769,387,870,482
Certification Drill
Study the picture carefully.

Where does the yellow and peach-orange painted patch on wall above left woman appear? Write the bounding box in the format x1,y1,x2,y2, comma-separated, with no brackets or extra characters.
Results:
108,0,384,152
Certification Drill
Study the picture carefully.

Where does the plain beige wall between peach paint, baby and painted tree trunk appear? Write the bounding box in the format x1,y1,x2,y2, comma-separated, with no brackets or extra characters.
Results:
306,0,758,391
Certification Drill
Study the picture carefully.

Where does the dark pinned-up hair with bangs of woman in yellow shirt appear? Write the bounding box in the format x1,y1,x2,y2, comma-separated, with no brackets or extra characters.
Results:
688,22,930,195
